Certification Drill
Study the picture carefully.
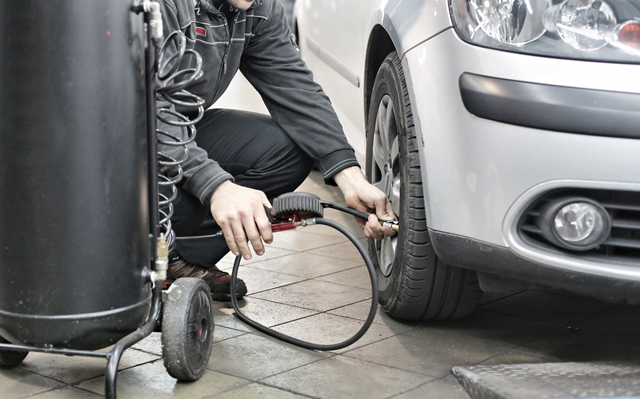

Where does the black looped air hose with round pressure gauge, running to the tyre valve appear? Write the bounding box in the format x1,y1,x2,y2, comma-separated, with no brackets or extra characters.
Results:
231,193,388,351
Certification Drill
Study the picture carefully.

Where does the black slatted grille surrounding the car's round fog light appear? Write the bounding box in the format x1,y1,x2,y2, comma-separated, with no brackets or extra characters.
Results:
518,188,640,265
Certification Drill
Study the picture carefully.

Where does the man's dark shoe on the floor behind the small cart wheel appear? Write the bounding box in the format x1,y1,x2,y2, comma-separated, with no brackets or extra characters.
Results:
162,253,247,301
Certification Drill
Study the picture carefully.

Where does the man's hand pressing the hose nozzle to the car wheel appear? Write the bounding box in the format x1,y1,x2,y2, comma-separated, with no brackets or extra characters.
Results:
333,166,396,240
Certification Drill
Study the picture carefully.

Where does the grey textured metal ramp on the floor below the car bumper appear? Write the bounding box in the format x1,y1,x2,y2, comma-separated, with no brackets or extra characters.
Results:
453,363,640,399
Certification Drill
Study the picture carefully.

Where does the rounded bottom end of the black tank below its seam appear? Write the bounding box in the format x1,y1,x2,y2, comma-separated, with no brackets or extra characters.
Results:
0,297,151,350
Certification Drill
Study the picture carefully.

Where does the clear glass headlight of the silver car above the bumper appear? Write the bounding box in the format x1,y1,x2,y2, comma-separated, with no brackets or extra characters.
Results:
451,0,640,63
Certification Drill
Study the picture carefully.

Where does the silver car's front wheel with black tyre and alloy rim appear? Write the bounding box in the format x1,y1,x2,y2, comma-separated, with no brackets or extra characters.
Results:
366,52,482,320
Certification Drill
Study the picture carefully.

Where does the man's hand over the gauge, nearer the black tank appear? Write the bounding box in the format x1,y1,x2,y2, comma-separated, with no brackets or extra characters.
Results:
210,181,273,259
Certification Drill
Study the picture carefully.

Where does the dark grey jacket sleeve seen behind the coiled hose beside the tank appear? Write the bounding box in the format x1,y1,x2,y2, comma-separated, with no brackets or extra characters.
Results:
156,0,233,205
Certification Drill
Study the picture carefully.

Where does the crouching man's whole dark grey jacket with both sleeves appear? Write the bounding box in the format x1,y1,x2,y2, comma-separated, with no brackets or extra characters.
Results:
158,0,358,204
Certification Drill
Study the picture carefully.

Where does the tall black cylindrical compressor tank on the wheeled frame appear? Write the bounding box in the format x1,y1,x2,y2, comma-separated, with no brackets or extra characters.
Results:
0,0,151,350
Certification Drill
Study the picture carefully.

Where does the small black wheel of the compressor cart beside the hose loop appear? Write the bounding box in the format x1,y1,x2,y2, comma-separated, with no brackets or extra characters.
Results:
162,278,214,381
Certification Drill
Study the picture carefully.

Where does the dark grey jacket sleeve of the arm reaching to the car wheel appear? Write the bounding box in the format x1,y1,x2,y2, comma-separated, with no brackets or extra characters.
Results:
240,0,359,184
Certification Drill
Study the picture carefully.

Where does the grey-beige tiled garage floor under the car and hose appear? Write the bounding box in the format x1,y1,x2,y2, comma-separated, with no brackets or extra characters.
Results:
0,76,640,399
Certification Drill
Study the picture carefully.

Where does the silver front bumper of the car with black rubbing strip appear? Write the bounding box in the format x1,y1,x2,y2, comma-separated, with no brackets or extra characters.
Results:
403,29,640,288
